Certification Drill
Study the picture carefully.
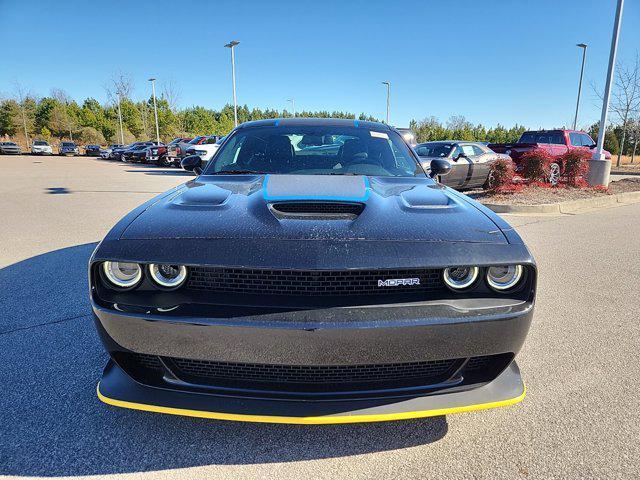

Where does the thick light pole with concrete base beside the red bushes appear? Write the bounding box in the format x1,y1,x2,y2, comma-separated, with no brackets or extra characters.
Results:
588,0,624,187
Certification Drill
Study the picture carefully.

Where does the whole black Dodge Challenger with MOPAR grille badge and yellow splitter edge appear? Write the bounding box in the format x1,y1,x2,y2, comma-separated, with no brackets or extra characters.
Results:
89,118,536,423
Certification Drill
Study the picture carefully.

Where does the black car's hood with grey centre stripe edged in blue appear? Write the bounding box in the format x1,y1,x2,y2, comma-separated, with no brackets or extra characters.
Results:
120,175,508,244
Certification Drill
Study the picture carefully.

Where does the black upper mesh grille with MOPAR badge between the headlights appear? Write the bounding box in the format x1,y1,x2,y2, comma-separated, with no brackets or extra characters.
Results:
187,267,443,296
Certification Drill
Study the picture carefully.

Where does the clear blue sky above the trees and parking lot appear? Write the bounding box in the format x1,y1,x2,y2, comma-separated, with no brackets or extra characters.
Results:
0,0,640,128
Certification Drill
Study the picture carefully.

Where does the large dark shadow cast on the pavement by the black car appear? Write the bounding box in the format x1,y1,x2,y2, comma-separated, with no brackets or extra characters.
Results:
0,243,447,477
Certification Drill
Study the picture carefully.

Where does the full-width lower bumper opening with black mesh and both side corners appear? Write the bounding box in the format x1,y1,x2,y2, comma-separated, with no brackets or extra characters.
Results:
114,352,513,394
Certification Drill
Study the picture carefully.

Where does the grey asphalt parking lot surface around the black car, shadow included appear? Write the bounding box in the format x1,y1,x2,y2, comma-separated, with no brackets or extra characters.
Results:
0,156,640,480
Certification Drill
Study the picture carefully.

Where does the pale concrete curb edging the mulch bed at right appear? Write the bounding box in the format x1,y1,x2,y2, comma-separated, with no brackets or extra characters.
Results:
483,191,640,214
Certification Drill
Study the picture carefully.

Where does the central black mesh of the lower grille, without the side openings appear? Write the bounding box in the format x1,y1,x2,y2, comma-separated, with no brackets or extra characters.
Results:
171,358,459,384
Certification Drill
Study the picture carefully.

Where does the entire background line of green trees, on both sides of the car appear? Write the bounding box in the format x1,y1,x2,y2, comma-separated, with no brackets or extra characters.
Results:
0,89,640,159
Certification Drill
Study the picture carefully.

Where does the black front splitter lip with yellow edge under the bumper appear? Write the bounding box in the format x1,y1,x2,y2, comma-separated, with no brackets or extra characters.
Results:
97,360,526,425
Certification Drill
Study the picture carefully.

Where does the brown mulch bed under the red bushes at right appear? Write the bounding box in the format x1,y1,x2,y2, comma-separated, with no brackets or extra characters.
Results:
465,178,640,205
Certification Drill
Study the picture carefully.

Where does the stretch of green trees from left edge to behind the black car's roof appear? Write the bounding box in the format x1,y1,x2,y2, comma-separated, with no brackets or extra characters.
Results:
0,90,375,145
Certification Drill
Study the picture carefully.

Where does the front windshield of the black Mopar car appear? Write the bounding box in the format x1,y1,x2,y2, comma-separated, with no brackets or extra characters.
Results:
204,125,424,177
